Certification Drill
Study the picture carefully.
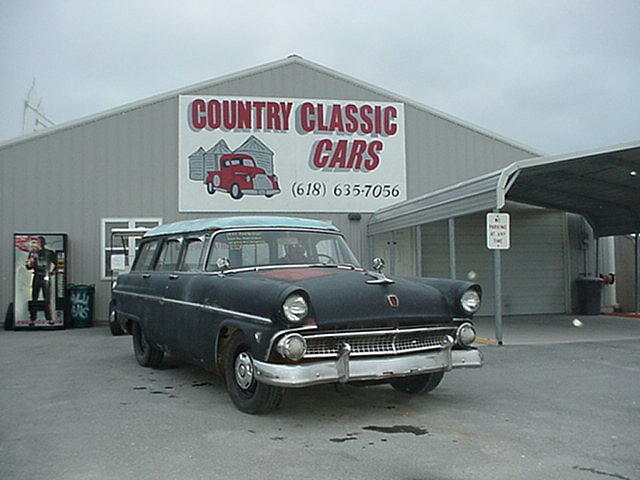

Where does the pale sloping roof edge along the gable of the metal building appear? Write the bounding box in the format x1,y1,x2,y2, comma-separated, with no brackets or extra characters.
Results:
0,54,544,156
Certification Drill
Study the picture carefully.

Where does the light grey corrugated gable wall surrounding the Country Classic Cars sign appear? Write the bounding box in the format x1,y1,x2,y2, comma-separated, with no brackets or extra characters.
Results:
0,59,548,319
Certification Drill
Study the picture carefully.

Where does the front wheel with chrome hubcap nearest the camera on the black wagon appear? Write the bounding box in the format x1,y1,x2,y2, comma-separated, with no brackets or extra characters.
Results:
224,333,284,414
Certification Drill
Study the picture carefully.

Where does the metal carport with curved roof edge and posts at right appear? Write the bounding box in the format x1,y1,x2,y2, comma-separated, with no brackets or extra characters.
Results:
367,142,640,344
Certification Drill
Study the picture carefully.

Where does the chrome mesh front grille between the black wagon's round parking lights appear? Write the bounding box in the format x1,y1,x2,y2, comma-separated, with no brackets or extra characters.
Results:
304,327,455,359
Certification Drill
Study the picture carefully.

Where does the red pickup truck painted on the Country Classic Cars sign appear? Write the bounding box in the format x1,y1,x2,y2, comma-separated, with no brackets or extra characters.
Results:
204,153,280,200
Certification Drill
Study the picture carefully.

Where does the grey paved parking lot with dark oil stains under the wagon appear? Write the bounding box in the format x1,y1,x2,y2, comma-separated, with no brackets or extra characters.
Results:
0,317,640,480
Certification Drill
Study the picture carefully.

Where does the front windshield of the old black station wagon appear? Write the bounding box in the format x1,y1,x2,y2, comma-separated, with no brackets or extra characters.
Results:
207,230,358,272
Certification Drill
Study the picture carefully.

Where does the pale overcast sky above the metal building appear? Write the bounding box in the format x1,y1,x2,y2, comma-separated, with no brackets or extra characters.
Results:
0,0,640,153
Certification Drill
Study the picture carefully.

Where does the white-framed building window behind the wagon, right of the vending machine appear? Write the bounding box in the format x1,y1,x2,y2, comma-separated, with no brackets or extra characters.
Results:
100,218,162,280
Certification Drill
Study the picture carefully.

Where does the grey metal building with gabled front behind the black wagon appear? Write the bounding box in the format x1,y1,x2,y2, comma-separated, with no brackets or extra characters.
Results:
0,56,632,326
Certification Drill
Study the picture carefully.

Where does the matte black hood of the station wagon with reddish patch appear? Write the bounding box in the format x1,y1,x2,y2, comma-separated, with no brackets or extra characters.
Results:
220,267,453,329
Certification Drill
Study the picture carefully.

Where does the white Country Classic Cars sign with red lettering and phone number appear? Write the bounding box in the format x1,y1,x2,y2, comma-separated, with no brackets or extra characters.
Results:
178,95,407,212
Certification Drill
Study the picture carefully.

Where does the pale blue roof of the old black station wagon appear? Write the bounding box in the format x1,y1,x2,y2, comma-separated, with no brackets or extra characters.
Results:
144,216,338,238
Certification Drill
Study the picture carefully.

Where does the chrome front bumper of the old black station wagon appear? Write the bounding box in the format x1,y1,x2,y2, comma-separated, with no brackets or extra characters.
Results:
253,348,483,387
